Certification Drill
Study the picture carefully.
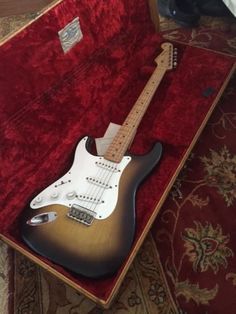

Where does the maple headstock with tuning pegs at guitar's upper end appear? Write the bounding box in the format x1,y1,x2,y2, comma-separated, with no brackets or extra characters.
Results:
155,43,177,70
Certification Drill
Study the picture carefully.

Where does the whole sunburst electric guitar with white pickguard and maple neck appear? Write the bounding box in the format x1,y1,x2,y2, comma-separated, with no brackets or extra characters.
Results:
21,43,176,278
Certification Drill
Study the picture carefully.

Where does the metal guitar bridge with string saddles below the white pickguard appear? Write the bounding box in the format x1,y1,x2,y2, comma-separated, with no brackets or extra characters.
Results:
67,204,96,226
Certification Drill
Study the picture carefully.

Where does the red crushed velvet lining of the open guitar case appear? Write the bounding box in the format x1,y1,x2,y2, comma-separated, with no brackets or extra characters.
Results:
0,0,233,300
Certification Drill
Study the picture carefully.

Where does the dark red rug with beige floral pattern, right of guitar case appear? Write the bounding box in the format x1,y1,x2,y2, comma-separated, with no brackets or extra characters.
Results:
152,71,236,314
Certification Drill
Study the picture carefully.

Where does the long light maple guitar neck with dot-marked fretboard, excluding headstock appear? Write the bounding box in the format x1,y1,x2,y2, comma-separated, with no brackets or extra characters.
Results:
104,67,166,163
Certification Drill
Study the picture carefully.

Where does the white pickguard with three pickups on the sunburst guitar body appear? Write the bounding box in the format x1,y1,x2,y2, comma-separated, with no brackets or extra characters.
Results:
30,137,131,219
